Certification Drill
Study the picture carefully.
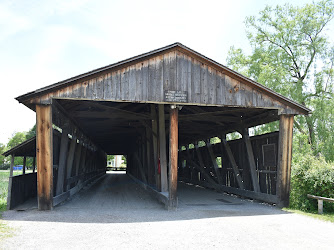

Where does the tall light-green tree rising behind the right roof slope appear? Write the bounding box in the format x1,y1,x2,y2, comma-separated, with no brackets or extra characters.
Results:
227,0,334,160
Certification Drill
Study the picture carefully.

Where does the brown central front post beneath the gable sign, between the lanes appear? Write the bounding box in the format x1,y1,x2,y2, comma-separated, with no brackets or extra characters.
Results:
168,105,178,209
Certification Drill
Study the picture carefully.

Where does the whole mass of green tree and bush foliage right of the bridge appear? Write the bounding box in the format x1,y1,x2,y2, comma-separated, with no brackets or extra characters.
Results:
227,0,334,212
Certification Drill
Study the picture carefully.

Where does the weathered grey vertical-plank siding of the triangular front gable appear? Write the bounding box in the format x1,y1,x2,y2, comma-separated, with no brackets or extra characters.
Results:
29,49,300,114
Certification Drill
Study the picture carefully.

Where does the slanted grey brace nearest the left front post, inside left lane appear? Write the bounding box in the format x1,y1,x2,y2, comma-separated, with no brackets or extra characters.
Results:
56,128,69,196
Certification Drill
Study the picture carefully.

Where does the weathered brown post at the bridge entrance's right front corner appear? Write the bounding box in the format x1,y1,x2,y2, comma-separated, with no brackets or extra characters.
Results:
277,115,293,207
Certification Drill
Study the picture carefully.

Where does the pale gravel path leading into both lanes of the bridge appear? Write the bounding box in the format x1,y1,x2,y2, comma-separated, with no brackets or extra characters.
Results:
0,174,334,249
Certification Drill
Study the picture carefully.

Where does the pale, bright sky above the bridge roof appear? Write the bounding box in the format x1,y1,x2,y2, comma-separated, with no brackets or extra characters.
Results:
0,0,328,144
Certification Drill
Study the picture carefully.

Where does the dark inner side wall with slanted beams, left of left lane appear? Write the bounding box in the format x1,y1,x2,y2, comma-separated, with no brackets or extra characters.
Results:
52,102,107,206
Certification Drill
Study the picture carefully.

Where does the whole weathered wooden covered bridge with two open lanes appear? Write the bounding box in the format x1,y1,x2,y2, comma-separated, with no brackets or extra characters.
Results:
5,43,310,210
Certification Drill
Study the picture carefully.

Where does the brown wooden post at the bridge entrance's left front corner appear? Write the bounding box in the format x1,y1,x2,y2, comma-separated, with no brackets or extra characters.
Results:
36,105,53,210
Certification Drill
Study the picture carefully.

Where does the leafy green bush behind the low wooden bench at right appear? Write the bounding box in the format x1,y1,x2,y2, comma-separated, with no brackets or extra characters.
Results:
290,154,334,212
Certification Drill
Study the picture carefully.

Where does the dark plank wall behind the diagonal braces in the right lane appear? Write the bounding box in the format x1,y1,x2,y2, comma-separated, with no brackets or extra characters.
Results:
179,132,279,196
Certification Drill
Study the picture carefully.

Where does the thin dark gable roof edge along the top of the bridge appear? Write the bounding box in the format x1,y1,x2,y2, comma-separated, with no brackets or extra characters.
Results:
15,43,311,114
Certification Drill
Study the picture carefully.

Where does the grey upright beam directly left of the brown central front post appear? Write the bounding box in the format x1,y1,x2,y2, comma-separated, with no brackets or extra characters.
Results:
158,104,168,192
